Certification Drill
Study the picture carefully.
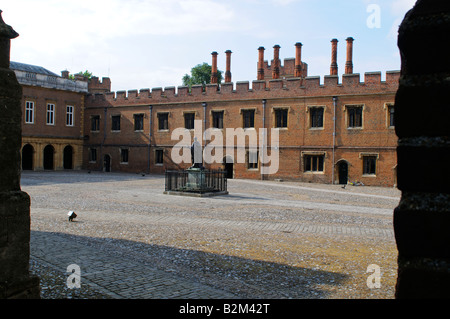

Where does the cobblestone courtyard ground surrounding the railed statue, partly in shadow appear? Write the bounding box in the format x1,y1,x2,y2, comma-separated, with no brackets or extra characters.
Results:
21,171,400,299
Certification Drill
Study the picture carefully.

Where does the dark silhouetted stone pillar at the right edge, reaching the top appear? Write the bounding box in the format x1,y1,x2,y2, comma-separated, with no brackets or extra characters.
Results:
394,0,450,298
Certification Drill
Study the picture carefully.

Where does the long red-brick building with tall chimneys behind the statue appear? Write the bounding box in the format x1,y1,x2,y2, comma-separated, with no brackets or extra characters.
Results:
83,38,400,186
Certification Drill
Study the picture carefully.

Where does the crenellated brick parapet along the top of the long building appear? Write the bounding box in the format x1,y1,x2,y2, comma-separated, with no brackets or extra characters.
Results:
86,71,400,107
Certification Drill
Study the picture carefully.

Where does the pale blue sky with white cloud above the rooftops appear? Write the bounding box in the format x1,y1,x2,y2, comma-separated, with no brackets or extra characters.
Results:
0,0,415,91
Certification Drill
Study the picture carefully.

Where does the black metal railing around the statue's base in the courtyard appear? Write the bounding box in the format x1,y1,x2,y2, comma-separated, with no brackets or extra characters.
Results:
165,169,227,193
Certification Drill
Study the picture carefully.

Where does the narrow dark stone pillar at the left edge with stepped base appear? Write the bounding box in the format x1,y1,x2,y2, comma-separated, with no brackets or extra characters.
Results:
0,10,40,299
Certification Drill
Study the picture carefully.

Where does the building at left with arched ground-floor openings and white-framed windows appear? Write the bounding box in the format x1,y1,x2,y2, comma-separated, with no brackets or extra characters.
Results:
10,62,88,170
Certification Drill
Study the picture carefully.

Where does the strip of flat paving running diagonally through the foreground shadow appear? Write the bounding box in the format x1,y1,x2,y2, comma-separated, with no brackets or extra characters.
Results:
31,232,236,299
